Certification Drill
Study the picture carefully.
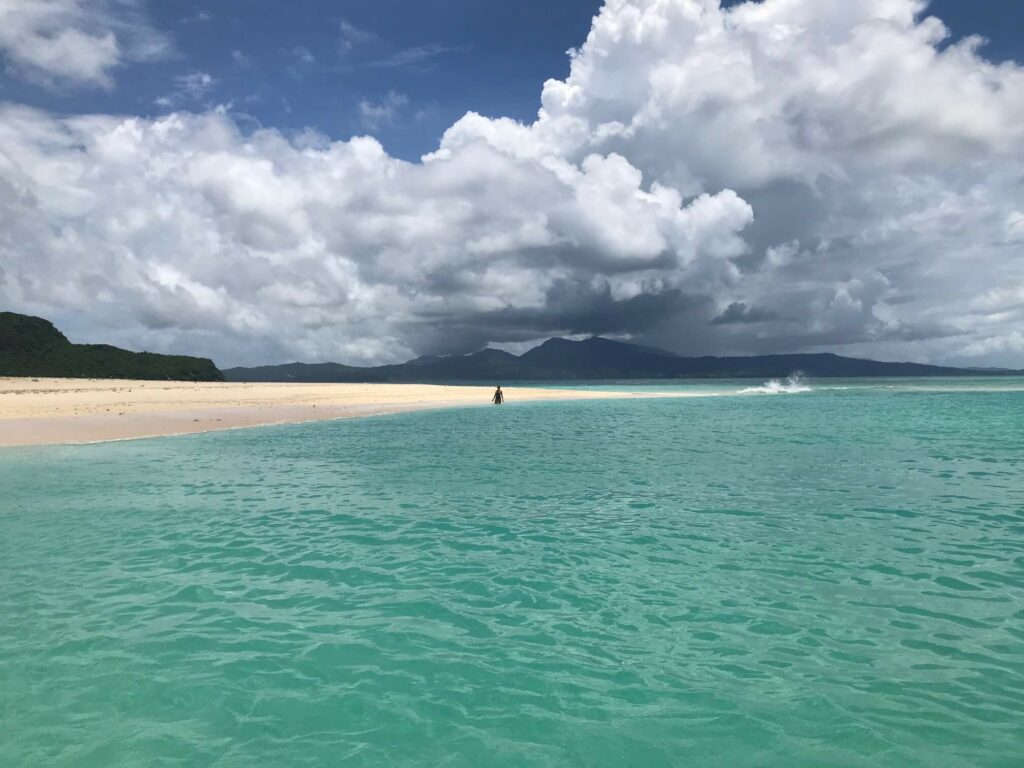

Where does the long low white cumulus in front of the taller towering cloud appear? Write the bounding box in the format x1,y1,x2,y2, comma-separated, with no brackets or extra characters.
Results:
0,101,751,362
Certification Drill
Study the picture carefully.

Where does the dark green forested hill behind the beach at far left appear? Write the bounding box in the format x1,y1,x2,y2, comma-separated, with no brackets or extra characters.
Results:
0,312,224,381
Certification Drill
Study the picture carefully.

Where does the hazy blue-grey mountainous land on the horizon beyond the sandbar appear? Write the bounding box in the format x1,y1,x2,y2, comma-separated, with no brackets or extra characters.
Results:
224,337,1021,383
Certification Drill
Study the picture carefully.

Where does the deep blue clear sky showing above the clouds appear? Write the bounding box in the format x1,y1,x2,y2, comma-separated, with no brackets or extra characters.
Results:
0,0,1024,160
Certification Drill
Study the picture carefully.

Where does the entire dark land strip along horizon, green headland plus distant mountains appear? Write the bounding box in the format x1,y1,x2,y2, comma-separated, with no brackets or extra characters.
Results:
6,312,1024,385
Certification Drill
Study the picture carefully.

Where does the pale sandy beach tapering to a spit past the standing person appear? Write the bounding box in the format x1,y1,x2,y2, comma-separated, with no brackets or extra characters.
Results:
0,378,636,445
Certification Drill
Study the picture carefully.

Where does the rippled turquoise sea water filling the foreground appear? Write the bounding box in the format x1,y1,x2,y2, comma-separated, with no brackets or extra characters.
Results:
0,380,1024,768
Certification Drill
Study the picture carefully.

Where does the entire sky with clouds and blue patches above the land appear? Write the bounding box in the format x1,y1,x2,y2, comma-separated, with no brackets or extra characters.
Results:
0,0,1024,368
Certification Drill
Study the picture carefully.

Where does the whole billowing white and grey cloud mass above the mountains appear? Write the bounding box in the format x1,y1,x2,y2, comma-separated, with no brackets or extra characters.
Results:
0,0,1024,367
